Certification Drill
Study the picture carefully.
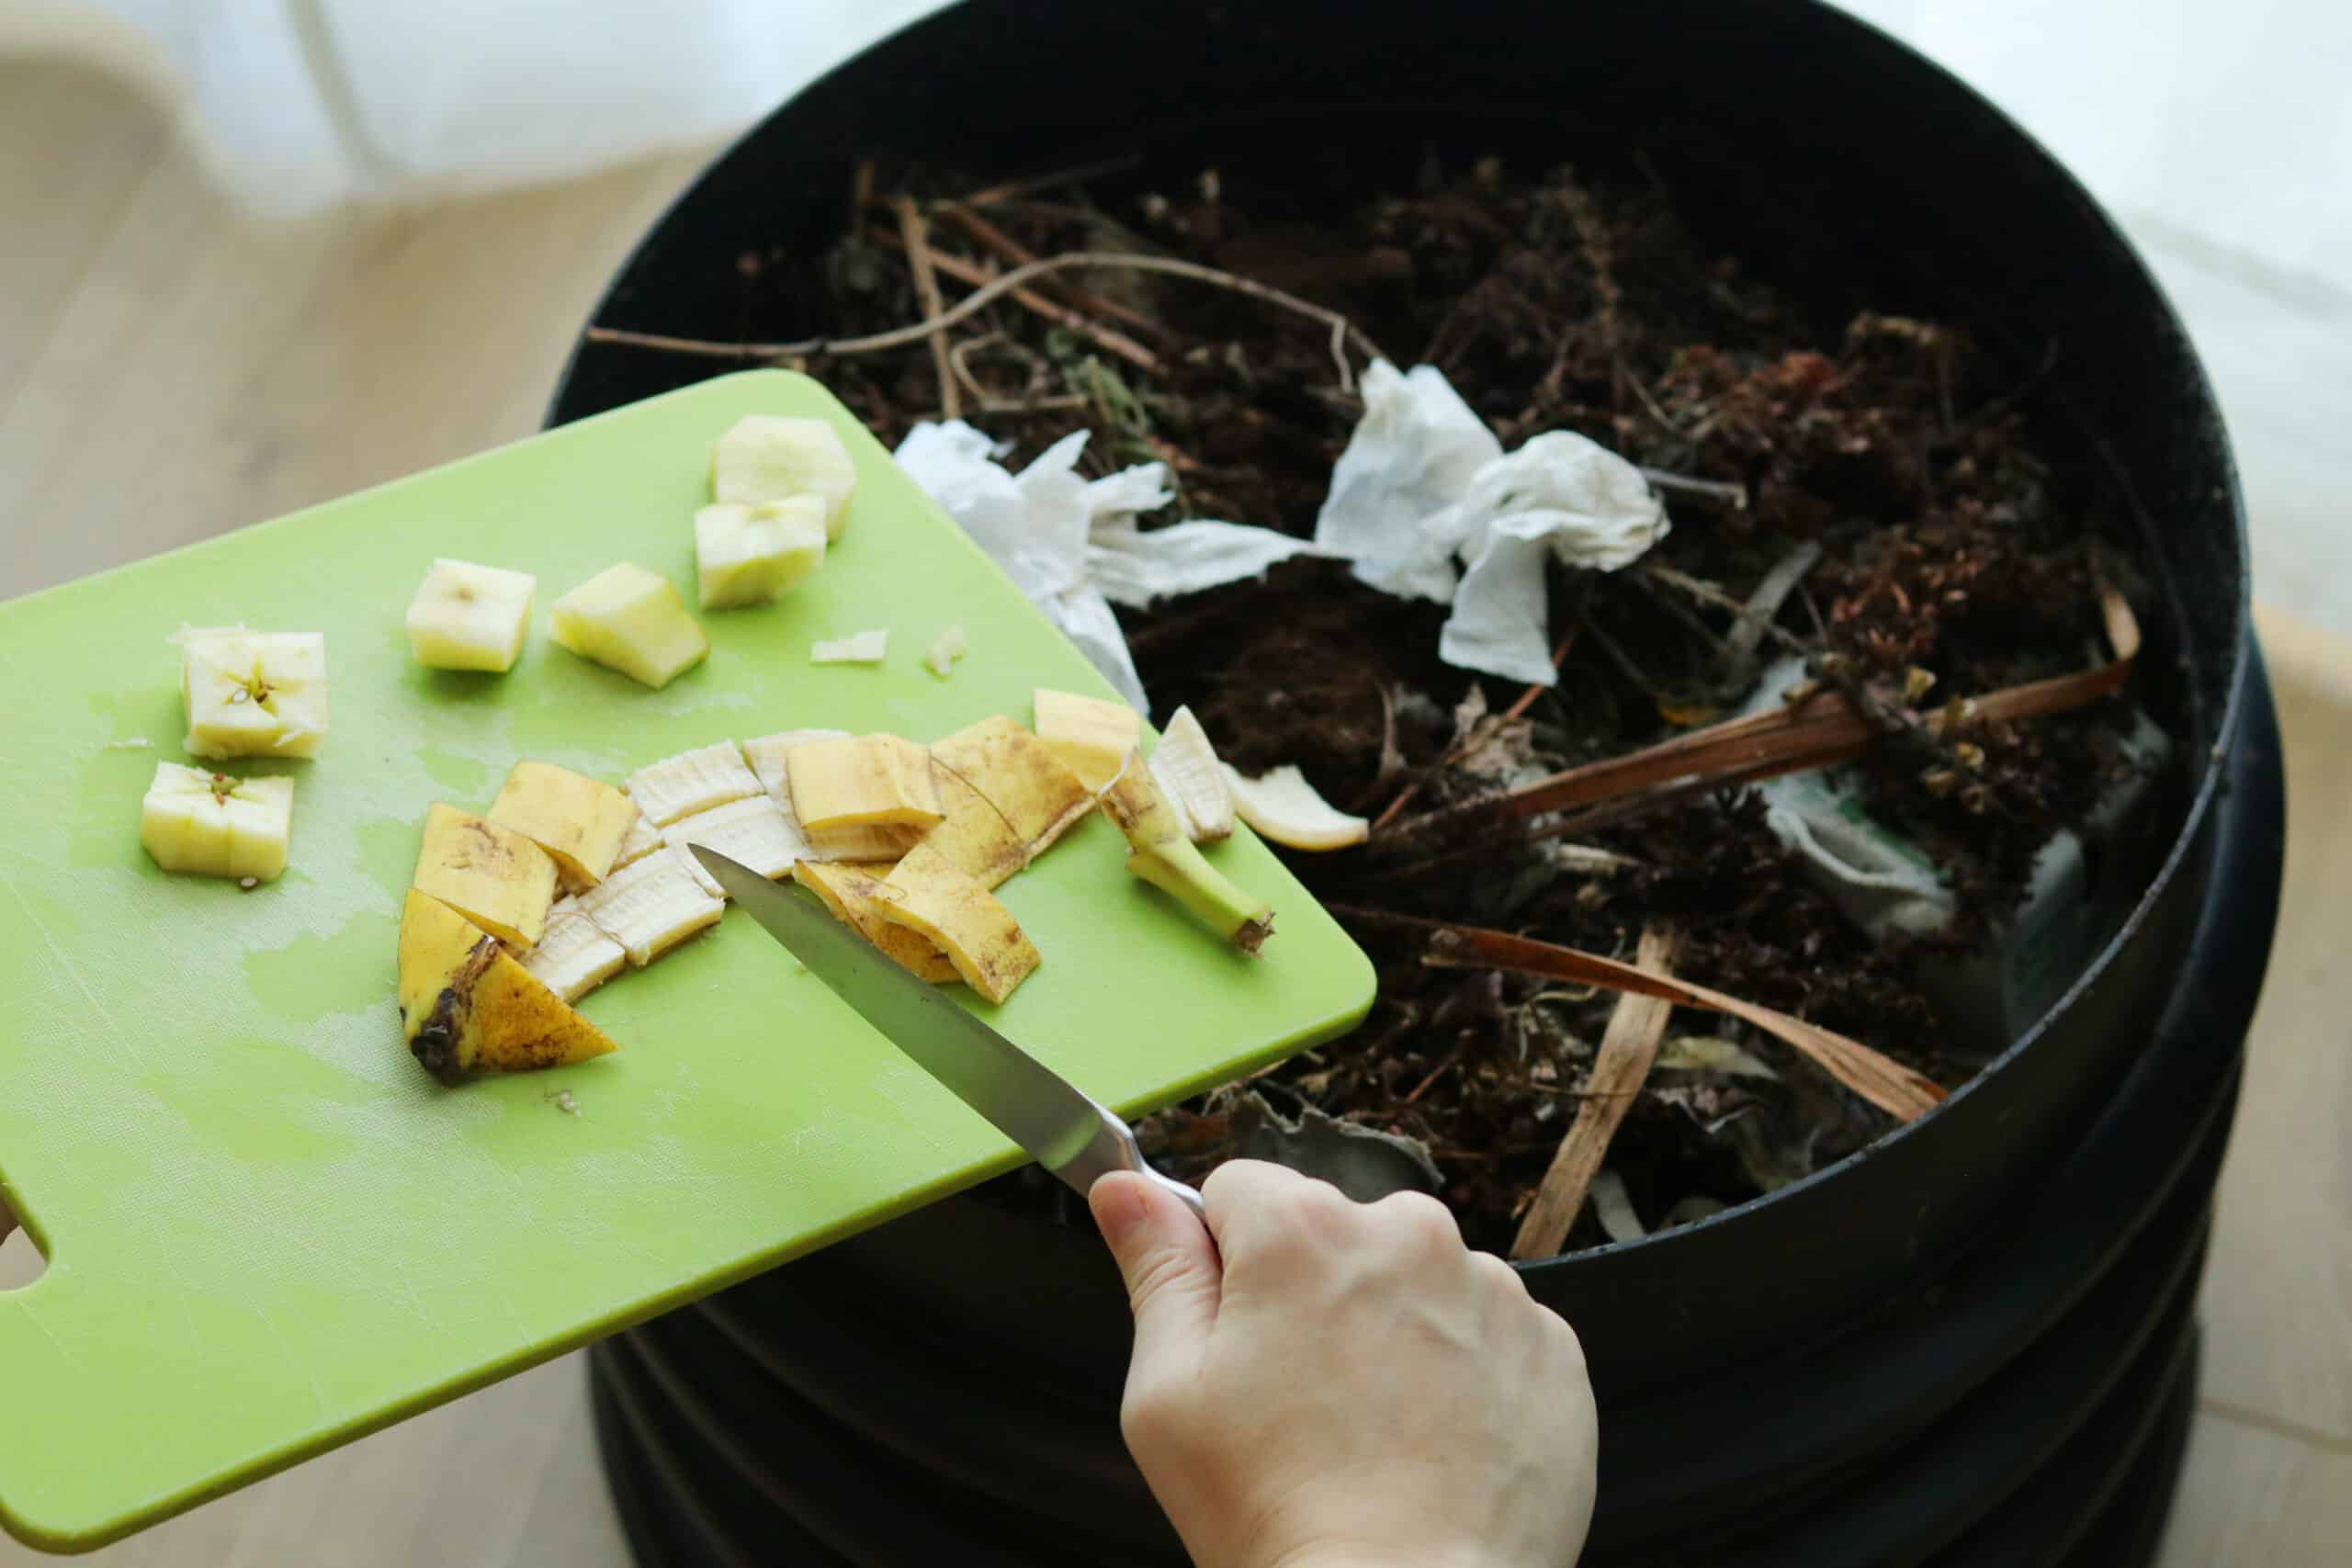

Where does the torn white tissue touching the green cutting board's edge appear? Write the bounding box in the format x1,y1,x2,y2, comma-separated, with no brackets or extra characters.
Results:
894,419,1331,712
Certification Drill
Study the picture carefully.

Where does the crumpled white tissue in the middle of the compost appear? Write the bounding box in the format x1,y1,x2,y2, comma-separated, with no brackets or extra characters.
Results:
1315,360,1670,686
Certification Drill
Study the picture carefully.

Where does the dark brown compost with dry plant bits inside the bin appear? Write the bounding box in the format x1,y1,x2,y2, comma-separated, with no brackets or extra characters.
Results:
710,146,2164,1251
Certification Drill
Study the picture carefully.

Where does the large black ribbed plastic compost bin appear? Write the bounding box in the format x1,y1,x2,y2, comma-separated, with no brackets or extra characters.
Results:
550,0,2284,1563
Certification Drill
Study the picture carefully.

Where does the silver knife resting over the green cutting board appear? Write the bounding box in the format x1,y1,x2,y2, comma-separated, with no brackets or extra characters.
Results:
692,844,1206,1220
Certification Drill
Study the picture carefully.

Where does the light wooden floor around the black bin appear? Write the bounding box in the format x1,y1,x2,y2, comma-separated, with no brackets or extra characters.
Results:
0,62,2352,1568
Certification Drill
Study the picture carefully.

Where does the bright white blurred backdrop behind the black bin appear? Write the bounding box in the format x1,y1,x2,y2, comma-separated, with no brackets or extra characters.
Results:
0,0,2352,632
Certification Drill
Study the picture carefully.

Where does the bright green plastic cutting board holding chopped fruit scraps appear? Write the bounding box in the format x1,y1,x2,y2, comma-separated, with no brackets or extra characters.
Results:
0,371,1374,1550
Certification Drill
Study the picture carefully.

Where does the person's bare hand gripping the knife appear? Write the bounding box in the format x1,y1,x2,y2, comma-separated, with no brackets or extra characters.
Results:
1087,1159,1600,1568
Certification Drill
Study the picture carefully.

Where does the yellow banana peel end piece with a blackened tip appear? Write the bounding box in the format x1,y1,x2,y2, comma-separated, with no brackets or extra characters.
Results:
400,888,621,1084
